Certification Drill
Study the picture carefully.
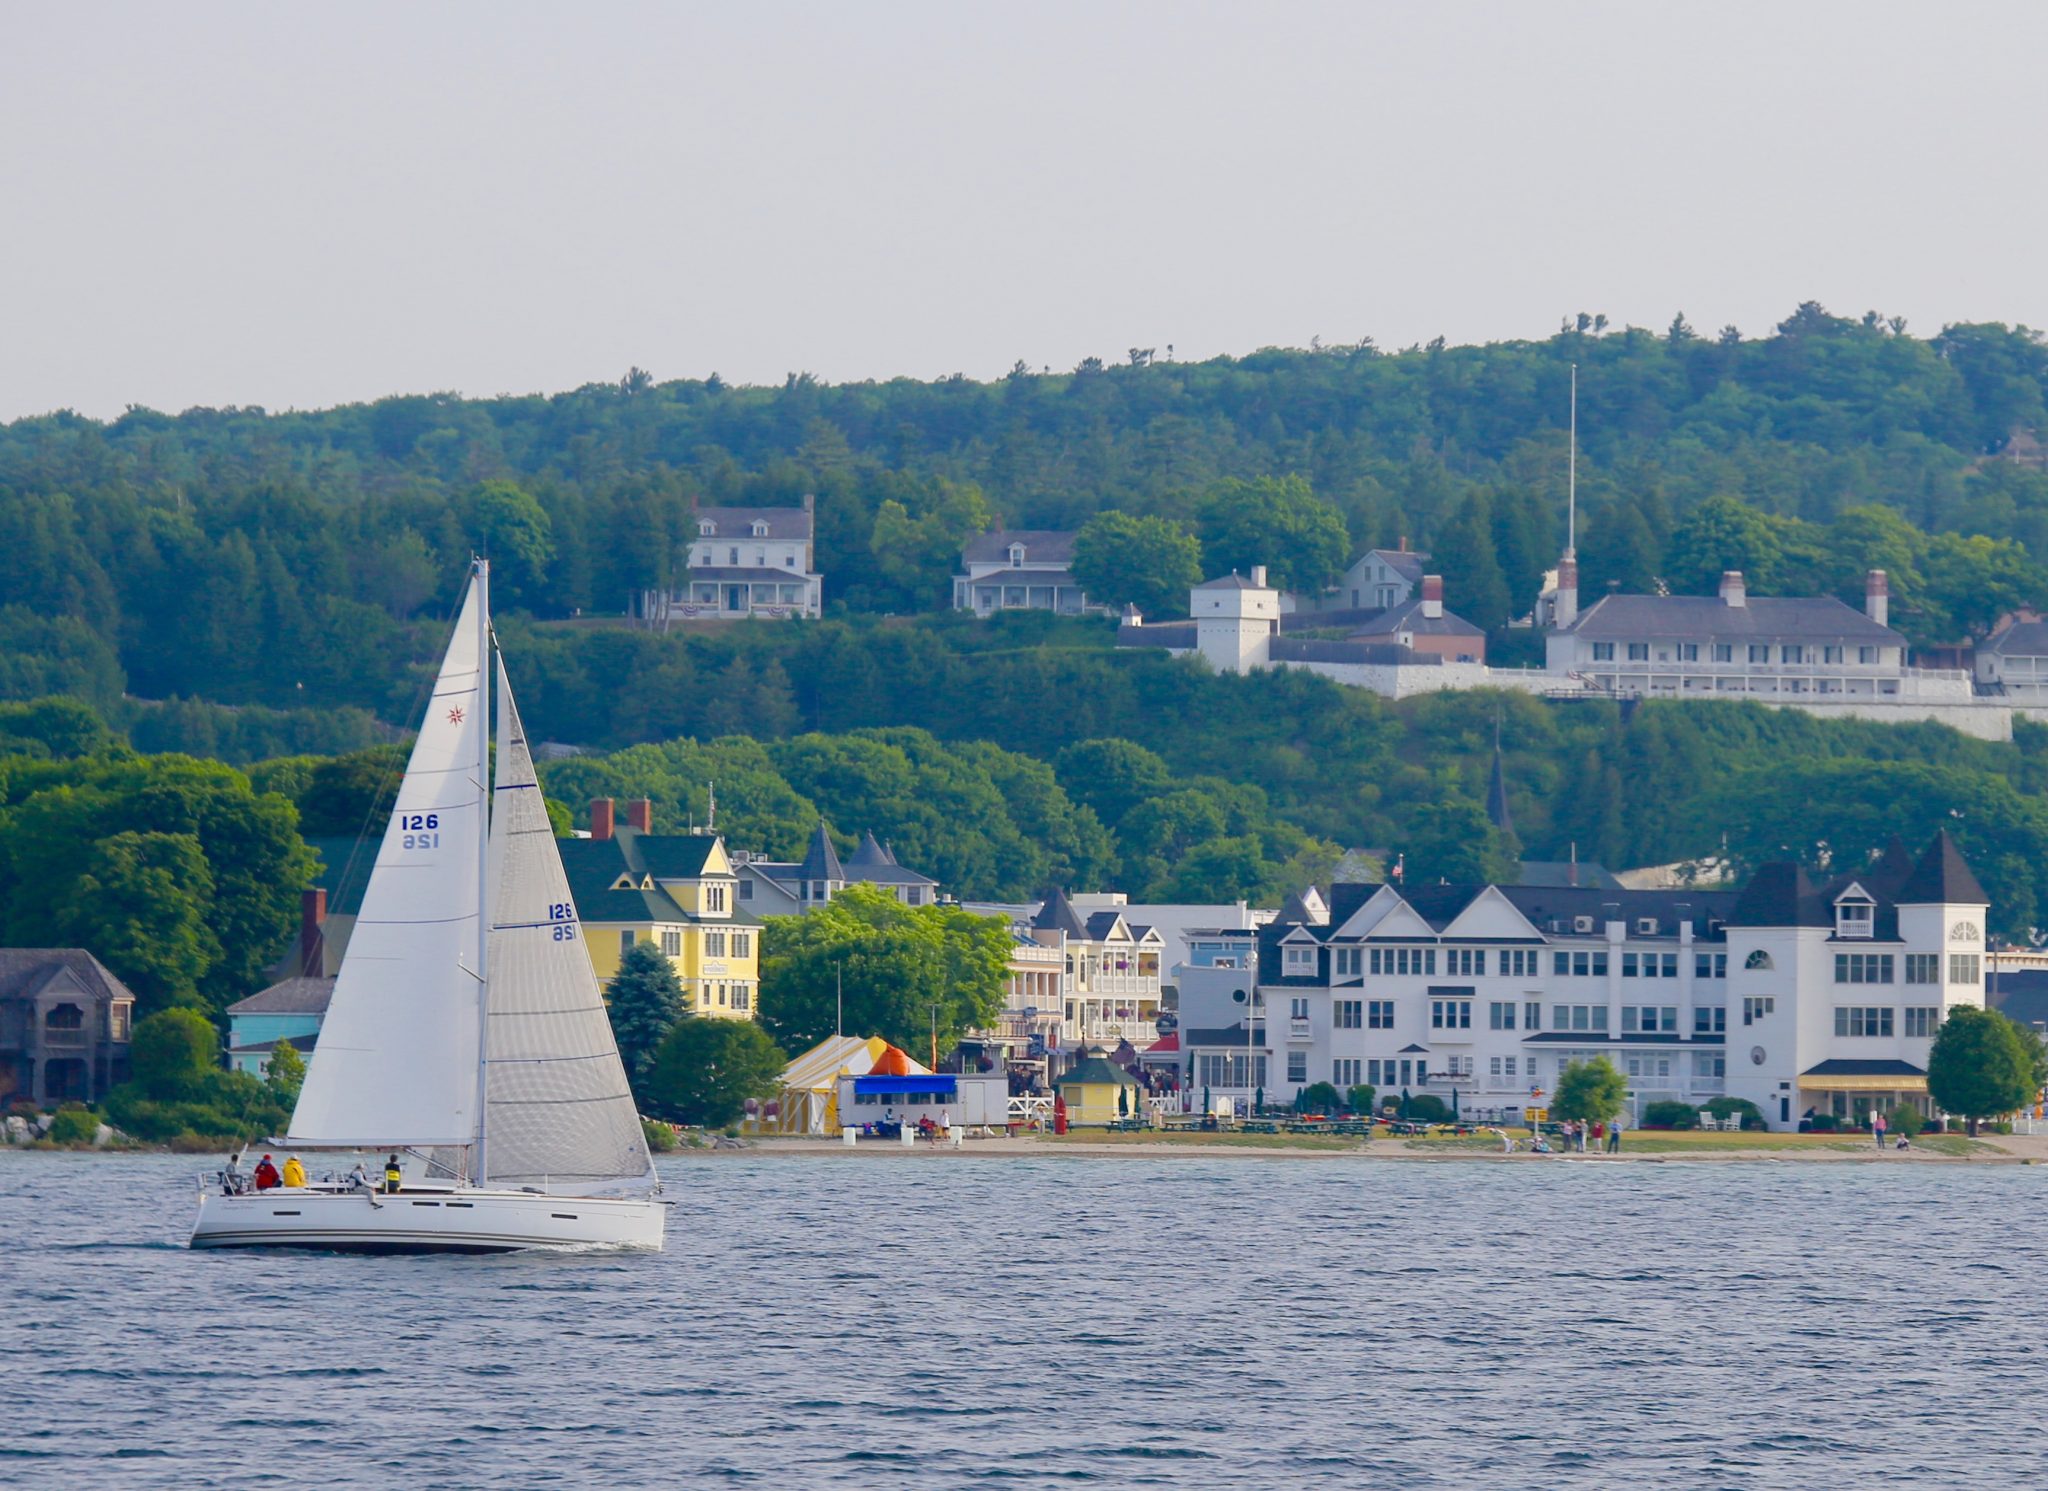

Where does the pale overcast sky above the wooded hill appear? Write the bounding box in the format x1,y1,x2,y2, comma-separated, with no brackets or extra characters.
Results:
0,0,2048,418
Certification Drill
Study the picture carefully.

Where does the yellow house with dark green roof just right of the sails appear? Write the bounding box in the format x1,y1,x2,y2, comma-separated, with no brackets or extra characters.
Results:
557,797,760,1020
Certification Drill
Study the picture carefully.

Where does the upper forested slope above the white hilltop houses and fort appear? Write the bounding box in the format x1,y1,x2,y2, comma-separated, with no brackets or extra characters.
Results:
12,305,2048,720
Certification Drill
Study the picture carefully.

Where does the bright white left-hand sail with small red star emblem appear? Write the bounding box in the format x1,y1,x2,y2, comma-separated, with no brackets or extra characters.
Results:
285,580,485,1149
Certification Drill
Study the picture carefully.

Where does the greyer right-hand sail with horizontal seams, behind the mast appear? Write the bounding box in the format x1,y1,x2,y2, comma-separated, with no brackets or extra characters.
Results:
483,662,653,1192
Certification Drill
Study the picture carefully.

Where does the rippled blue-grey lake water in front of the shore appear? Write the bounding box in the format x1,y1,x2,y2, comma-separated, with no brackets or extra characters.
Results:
0,1155,2048,1491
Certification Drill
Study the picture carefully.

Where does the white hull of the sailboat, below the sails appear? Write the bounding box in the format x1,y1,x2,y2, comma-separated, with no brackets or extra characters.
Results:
193,1188,668,1253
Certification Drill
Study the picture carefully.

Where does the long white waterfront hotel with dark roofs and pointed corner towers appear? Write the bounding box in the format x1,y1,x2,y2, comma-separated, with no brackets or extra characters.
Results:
1236,834,1989,1128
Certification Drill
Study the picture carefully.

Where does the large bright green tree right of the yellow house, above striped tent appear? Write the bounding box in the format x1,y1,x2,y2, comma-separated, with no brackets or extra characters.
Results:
762,885,1010,1053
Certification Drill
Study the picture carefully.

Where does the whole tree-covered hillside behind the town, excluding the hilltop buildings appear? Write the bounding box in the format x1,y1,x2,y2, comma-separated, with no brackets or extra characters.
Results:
0,305,2048,962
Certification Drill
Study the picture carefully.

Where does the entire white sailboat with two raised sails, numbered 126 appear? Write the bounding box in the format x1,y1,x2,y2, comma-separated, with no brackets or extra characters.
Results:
193,559,666,1253
